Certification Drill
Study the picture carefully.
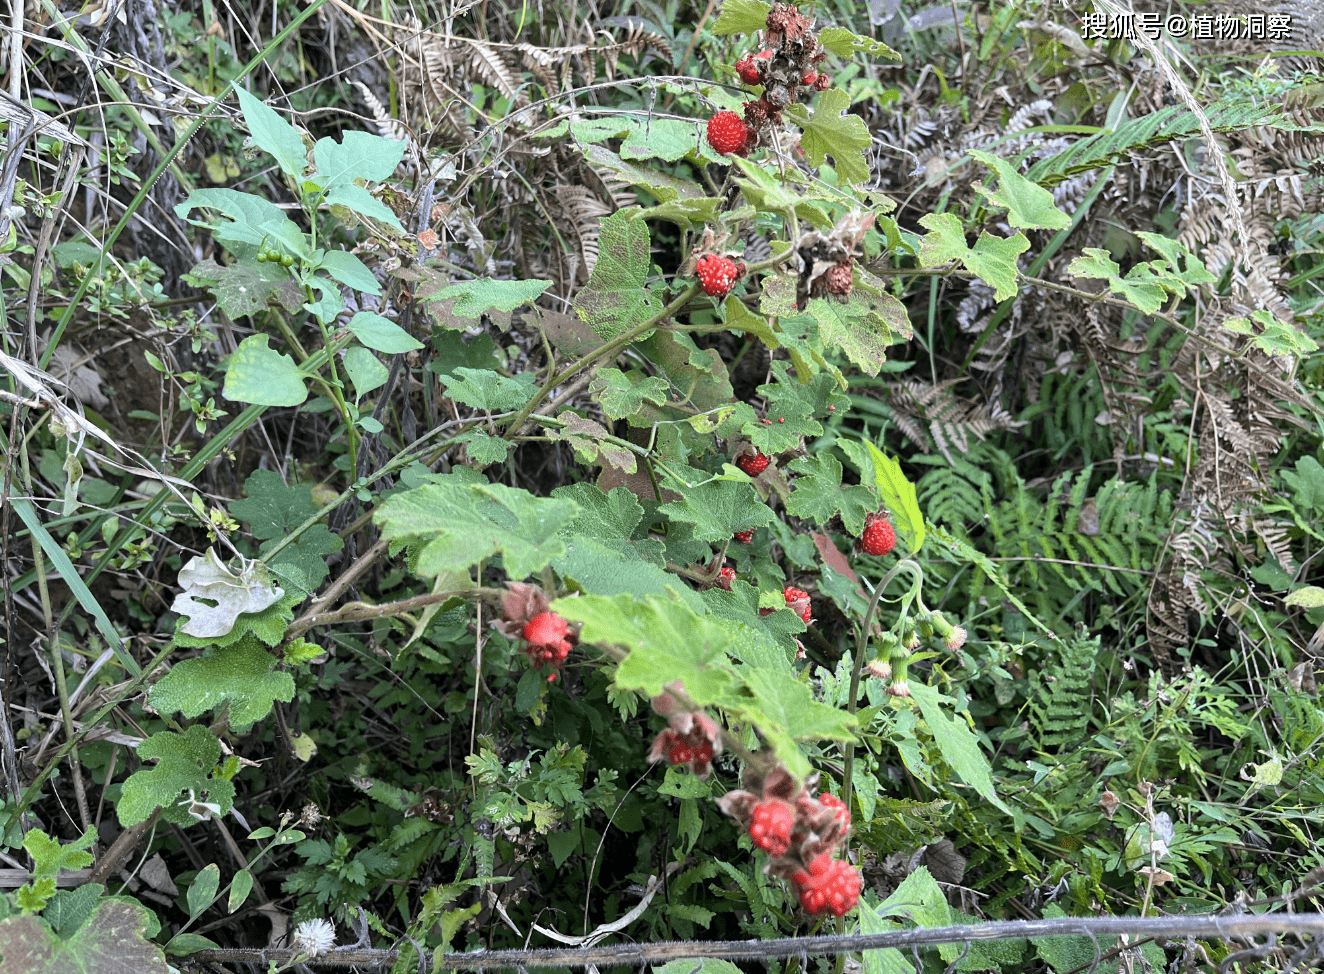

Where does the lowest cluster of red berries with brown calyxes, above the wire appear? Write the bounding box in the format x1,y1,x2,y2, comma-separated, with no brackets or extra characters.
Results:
718,766,861,917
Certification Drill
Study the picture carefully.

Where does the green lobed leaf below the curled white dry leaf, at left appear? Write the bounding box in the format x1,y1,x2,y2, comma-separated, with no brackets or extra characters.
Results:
147,638,294,733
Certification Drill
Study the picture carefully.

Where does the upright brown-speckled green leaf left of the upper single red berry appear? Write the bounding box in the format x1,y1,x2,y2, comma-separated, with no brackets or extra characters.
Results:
575,210,662,339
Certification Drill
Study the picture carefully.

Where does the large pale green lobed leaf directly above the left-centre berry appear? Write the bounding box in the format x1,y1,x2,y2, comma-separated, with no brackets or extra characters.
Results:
373,479,579,580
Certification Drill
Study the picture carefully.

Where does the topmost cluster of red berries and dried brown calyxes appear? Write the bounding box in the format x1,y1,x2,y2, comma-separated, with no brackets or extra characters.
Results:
708,3,831,156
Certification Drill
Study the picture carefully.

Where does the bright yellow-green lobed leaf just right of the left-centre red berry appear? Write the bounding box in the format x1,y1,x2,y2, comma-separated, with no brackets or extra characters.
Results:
552,596,732,707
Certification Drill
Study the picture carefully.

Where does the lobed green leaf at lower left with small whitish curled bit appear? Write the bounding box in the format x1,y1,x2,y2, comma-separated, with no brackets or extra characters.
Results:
115,724,234,828
